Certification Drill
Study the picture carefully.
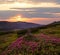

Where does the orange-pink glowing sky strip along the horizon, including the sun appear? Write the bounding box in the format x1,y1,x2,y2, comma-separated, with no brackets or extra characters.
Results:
6,15,60,24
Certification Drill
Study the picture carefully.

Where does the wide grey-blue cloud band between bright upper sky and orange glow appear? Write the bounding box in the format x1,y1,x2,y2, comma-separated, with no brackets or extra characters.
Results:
0,7,60,19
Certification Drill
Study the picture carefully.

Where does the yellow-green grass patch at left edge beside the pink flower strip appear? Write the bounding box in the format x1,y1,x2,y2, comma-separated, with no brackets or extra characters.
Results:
0,33,17,52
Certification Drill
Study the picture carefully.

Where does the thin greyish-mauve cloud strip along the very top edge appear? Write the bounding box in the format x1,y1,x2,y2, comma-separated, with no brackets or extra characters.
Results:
0,0,60,4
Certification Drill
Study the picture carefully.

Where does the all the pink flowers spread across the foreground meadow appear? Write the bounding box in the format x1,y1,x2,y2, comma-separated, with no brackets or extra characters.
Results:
1,34,60,55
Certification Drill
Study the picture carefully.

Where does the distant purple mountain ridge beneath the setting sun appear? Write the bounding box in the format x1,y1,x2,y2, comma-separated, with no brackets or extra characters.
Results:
0,21,42,30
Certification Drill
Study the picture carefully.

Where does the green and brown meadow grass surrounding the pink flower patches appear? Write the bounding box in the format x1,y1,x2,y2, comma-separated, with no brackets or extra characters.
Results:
0,25,60,55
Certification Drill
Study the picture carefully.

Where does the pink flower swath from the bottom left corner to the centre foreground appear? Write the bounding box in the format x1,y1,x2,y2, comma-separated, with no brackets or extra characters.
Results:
1,37,38,55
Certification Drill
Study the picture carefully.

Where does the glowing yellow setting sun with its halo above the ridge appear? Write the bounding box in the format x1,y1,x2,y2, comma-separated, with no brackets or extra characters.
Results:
7,15,28,22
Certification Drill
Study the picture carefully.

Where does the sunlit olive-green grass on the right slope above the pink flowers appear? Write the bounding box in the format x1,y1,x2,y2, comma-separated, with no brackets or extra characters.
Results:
40,25,60,37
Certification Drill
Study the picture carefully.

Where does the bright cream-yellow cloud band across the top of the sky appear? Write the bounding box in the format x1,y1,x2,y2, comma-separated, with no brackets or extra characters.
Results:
0,0,60,7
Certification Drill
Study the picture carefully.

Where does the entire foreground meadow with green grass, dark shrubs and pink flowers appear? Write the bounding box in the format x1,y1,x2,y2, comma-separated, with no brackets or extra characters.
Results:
0,25,60,55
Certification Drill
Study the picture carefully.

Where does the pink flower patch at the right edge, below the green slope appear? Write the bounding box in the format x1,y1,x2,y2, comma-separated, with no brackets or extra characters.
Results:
40,34,60,43
